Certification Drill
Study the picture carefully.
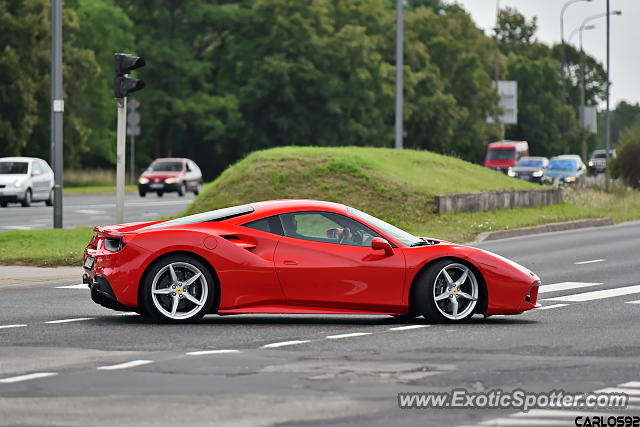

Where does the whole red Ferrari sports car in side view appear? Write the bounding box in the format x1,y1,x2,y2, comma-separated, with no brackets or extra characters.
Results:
83,200,540,322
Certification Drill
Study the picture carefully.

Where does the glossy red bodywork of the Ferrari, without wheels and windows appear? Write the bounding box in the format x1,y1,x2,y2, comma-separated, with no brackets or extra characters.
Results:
84,200,540,315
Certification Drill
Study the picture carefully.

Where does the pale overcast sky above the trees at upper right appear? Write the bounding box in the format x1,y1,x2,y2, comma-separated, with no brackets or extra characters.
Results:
451,0,640,108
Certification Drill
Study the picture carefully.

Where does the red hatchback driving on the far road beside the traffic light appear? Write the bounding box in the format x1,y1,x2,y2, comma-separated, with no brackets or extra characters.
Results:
138,158,202,197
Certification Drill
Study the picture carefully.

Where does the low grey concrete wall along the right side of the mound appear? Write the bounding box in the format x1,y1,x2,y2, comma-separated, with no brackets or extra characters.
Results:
435,188,563,213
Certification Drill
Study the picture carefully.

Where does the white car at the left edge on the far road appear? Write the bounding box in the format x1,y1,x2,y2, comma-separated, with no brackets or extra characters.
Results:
0,157,53,208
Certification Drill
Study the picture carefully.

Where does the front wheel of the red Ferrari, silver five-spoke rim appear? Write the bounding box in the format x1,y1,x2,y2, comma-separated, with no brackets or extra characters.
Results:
415,259,481,323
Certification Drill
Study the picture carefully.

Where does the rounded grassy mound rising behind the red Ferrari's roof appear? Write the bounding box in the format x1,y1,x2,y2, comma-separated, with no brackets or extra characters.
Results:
185,147,540,233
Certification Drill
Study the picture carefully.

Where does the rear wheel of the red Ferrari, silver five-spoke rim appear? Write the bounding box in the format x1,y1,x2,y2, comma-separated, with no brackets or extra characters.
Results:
139,255,217,323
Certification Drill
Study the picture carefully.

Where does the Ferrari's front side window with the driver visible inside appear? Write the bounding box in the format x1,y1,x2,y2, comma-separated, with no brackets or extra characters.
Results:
280,212,380,246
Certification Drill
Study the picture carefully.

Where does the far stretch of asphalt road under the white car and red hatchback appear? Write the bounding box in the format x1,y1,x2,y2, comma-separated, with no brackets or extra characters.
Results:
0,193,194,231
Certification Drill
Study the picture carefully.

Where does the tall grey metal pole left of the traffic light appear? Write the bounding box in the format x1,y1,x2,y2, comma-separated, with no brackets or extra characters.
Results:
51,0,64,228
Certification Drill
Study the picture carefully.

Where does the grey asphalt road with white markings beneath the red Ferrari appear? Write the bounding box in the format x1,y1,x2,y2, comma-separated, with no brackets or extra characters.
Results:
0,223,640,426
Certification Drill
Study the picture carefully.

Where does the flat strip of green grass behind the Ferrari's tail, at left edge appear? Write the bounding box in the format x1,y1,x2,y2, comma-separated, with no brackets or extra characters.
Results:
0,227,92,267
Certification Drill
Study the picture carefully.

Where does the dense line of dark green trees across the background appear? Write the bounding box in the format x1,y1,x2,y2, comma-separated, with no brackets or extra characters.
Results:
0,0,620,178
